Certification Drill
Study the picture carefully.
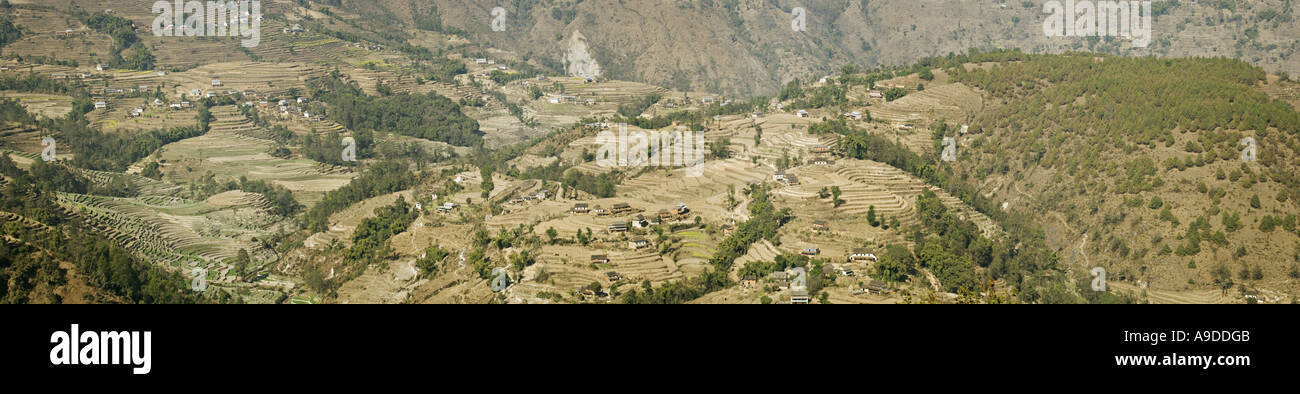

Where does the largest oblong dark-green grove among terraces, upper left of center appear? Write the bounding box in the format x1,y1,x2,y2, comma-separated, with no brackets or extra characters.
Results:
311,72,484,146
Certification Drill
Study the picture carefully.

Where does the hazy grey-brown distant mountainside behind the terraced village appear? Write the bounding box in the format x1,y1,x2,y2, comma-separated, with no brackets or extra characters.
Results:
327,0,1300,95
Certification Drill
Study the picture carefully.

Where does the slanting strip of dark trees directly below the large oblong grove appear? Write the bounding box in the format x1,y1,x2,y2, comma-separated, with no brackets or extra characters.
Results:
302,161,416,233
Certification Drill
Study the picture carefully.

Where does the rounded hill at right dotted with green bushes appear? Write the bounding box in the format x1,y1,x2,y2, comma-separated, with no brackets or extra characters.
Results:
781,52,1300,299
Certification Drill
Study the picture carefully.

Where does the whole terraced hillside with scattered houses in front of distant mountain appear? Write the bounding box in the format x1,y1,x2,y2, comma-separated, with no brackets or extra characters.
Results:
0,0,1300,304
